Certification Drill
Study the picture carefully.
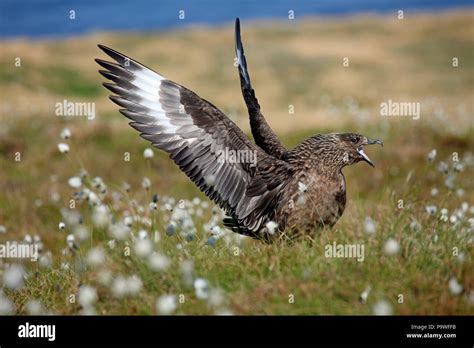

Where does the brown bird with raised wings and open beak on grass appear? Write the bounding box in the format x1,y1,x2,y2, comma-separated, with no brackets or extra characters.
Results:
95,18,383,242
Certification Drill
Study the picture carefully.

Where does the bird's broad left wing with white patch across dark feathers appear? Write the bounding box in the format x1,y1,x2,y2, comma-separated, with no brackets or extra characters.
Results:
96,45,290,235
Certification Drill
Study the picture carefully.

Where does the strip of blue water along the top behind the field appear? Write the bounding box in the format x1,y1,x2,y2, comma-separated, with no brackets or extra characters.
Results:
0,0,474,38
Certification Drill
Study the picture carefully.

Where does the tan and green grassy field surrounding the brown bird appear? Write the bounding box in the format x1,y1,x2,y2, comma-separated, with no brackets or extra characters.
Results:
0,13,474,315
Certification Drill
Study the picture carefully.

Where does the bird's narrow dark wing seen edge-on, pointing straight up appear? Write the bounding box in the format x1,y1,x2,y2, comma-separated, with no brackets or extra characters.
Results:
235,18,287,159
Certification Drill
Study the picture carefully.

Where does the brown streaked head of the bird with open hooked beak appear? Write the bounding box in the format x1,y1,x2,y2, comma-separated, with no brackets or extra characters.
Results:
302,133,383,170
